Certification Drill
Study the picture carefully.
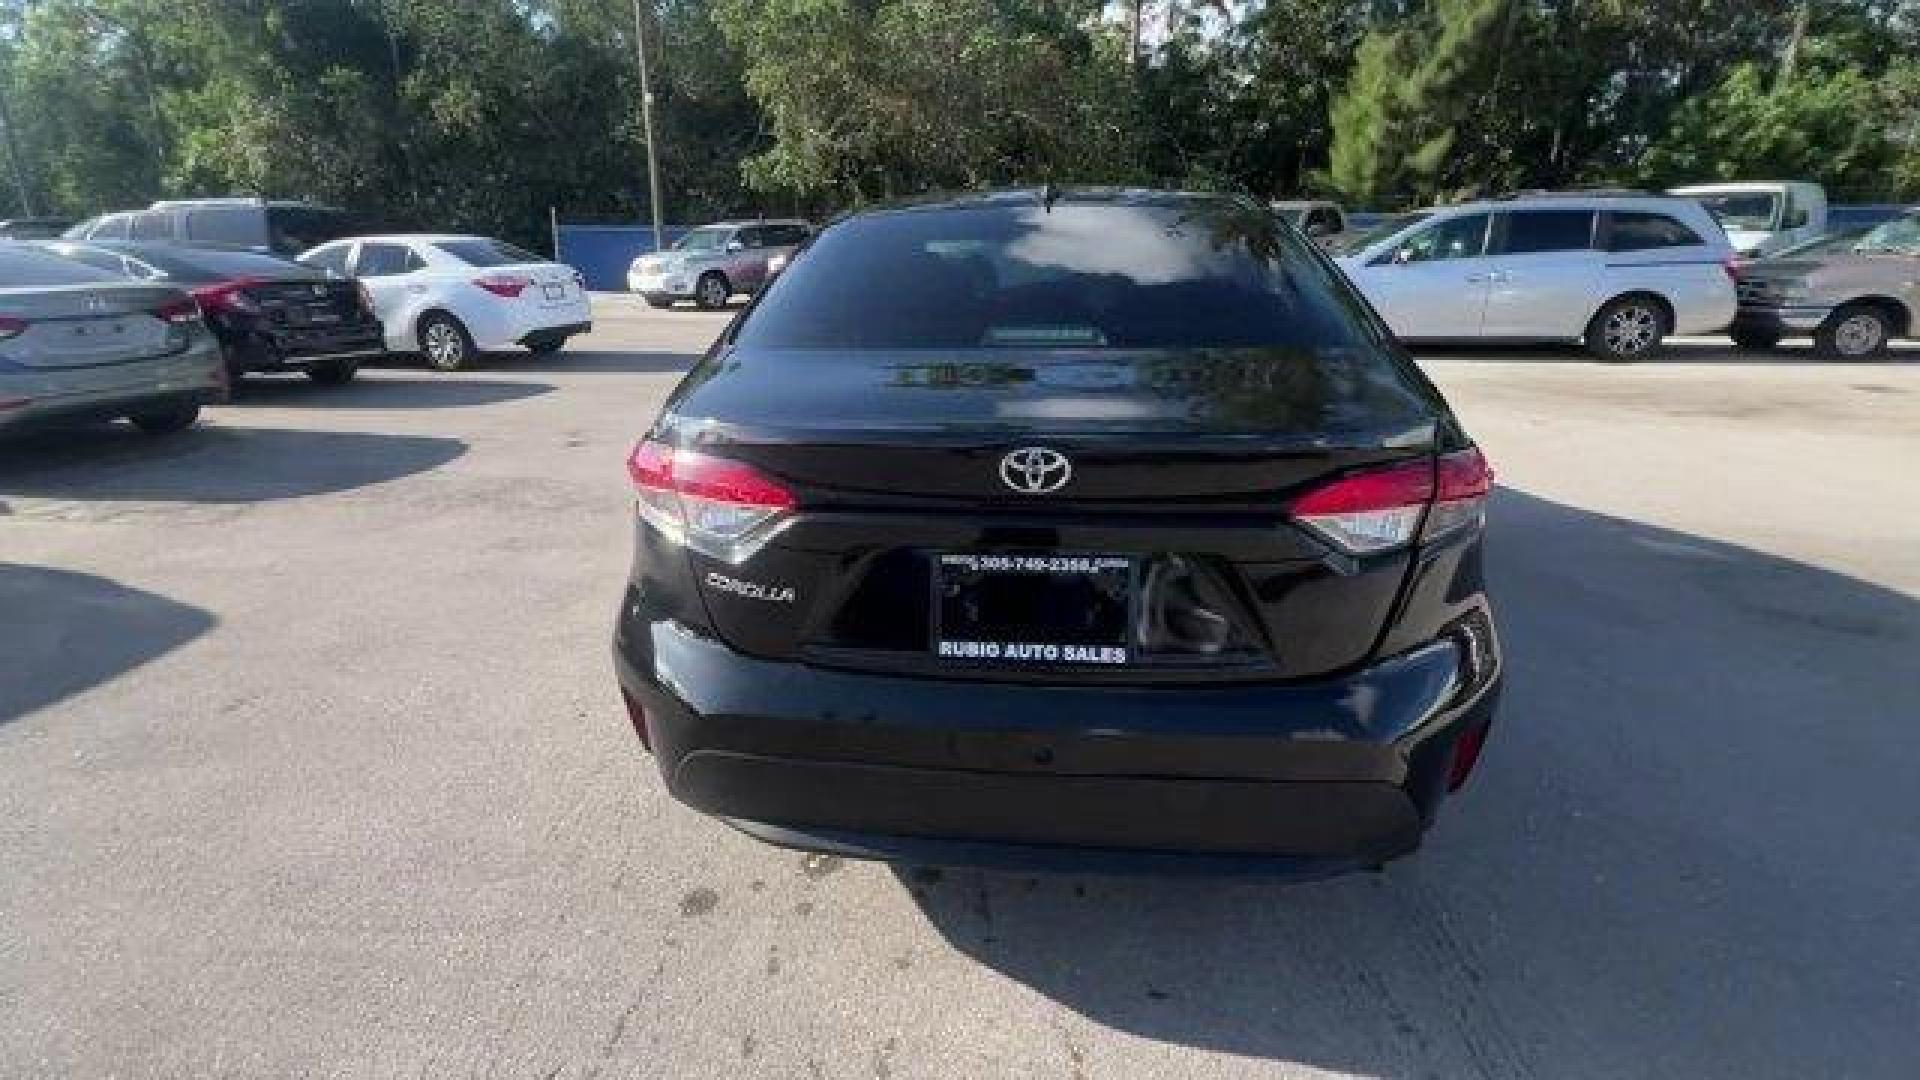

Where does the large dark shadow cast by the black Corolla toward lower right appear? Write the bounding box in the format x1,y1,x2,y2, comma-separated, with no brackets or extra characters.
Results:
899,490,1920,1078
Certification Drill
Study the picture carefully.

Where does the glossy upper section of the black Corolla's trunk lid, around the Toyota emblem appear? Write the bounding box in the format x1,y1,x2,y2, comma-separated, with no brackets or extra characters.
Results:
672,350,1436,511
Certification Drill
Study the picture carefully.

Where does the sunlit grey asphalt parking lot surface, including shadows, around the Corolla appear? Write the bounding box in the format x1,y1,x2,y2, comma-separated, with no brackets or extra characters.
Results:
0,298,1920,1080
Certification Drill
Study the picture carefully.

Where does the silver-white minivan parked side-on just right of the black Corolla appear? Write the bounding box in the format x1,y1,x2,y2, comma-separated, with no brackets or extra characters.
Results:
1336,192,1736,359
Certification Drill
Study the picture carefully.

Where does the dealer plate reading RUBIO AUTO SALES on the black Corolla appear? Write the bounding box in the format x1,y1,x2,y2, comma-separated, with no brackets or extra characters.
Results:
929,552,1142,671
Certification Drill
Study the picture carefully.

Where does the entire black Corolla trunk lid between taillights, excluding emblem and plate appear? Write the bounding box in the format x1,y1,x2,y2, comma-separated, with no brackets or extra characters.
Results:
666,350,1440,682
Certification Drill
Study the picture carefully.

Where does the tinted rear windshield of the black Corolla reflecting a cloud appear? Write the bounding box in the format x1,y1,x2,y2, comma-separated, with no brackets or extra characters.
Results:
735,198,1373,350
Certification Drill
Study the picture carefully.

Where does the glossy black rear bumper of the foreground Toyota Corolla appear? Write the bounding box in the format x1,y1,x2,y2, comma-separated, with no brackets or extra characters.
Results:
614,605,1500,876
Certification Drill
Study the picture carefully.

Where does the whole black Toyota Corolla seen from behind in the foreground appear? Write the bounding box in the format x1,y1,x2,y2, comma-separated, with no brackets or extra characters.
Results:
614,190,1501,872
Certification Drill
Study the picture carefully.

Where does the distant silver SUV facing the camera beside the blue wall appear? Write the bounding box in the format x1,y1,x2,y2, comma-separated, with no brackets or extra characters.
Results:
626,219,812,309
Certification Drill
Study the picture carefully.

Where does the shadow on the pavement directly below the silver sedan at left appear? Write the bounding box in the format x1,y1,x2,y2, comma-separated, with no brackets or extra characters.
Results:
0,425,467,503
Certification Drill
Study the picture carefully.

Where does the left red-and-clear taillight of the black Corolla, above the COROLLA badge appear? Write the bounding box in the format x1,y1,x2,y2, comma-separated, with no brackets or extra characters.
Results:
626,440,795,563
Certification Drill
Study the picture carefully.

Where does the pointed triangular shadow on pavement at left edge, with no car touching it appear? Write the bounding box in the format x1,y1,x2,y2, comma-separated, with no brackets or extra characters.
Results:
0,563,213,726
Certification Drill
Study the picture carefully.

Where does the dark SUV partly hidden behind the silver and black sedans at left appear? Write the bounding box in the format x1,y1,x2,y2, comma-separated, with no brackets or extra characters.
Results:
63,198,367,259
